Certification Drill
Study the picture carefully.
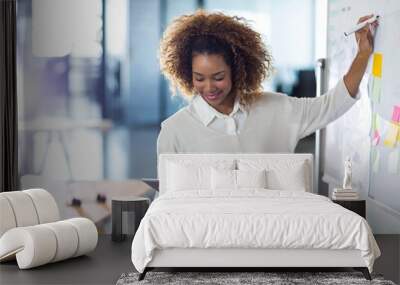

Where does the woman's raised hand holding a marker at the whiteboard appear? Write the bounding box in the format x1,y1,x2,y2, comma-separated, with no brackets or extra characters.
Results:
355,14,378,57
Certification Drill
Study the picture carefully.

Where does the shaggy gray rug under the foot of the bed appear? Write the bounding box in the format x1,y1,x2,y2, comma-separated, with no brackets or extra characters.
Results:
117,271,395,285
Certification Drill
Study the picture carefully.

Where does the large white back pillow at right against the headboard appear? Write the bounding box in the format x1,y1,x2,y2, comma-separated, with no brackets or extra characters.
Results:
238,159,311,191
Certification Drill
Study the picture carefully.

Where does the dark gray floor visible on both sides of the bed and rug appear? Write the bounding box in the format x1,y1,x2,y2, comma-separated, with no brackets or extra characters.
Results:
0,235,400,285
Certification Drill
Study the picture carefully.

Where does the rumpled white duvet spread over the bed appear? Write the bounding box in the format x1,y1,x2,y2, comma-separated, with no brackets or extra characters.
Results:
132,189,380,272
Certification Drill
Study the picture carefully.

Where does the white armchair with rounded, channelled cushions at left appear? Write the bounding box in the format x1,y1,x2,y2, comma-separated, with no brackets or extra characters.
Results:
0,189,98,269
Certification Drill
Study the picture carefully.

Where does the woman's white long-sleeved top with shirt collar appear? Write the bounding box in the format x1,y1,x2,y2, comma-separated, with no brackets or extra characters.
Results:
157,79,359,154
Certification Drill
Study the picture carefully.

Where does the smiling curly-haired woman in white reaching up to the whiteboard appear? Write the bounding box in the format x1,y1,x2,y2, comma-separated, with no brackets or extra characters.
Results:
157,11,377,154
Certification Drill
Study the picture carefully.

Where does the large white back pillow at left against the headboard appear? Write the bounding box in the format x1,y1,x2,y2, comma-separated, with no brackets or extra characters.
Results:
166,161,235,191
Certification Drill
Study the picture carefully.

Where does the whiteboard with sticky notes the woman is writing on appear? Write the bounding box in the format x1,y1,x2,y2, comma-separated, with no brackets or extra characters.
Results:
322,0,400,215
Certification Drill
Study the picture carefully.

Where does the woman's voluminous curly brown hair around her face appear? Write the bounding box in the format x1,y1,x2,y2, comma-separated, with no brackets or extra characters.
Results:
160,10,272,105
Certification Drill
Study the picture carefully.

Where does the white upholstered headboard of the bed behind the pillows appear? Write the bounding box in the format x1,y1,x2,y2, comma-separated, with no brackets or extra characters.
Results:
158,153,313,194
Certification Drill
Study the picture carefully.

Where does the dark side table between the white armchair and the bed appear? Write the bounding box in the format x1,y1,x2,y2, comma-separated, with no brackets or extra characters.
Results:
111,196,150,241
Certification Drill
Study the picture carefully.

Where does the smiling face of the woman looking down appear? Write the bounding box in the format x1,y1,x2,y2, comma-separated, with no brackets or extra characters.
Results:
192,53,235,114
